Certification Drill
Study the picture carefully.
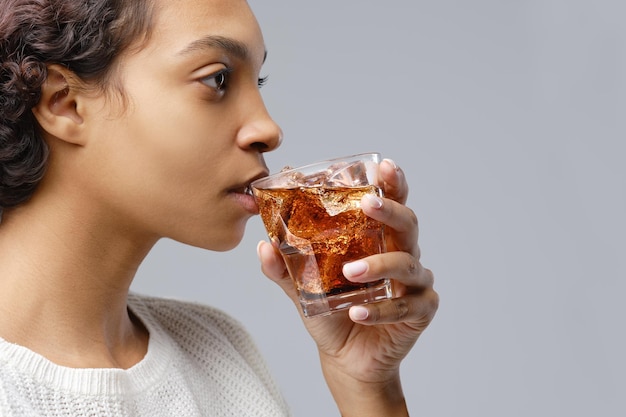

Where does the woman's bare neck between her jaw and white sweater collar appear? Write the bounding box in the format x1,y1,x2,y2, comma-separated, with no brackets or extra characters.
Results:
0,205,156,368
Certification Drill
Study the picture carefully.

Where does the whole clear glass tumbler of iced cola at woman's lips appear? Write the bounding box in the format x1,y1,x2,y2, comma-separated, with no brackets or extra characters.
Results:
252,154,391,317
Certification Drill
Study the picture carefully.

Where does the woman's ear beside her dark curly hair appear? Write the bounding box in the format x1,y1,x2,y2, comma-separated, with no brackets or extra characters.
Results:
32,65,84,145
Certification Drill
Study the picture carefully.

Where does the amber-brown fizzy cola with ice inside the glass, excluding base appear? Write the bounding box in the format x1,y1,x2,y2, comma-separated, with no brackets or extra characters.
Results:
255,184,385,298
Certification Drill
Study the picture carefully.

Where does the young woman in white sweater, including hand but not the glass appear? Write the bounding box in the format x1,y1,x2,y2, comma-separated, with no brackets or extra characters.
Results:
0,0,438,417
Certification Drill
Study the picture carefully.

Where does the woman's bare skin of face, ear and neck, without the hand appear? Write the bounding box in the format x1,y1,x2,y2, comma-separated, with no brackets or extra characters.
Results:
0,0,281,368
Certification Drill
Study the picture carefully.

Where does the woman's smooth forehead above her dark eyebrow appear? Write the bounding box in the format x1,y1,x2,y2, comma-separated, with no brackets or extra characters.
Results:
146,0,265,59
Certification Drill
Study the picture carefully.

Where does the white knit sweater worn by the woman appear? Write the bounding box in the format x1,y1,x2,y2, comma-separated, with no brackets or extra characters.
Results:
0,295,289,417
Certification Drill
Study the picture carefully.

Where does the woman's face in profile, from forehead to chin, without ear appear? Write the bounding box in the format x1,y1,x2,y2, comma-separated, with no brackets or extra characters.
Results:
73,0,281,250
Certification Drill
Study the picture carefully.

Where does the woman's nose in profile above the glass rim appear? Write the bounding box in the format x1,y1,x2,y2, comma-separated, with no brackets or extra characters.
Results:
237,100,283,152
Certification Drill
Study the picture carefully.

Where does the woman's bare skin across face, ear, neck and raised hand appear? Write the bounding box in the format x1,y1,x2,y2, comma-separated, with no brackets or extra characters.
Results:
0,0,437,417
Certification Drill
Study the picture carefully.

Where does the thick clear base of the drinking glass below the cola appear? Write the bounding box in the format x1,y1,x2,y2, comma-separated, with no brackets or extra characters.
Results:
299,279,393,317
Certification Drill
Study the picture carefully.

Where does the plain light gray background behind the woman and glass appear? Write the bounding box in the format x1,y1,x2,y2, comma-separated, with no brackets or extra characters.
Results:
133,0,626,417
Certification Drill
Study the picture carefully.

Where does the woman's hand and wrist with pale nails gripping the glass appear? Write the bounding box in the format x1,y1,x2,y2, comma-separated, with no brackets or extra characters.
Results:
258,160,439,416
